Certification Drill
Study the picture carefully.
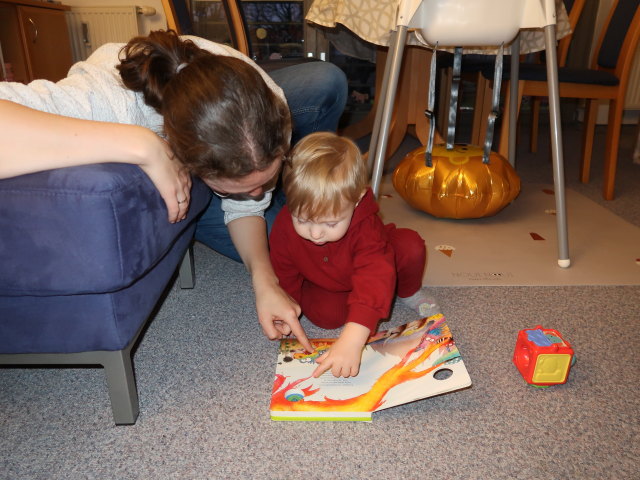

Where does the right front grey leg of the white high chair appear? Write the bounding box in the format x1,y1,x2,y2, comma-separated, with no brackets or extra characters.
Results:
544,25,571,268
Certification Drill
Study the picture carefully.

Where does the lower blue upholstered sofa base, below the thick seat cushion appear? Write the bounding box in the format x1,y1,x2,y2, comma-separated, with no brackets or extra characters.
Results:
0,222,195,354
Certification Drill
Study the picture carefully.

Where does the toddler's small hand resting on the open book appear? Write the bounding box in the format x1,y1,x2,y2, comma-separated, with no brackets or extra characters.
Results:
313,323,370,378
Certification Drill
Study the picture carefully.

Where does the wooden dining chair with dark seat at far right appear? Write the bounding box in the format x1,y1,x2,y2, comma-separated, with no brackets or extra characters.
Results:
490,0,640,200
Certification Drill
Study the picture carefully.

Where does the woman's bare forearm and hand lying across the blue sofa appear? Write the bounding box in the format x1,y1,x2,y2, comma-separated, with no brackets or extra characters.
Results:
0,100,191,222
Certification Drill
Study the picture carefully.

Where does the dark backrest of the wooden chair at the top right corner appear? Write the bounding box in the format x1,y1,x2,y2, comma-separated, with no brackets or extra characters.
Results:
592,0,640,75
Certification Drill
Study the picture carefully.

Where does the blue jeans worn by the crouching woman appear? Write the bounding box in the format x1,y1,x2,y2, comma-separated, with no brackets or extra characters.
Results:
195,62,347,262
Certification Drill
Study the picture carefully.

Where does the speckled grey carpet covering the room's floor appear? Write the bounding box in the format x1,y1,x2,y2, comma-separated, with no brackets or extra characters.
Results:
0,122,640,480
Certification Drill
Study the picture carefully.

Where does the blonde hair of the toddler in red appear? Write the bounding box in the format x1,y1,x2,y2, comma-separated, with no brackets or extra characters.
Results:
282,132,369,220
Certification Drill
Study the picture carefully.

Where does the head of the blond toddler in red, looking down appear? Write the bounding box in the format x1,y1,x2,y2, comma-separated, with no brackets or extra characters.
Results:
282,132,369,243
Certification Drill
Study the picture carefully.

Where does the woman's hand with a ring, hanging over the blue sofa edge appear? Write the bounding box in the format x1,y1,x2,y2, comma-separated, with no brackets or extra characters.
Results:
140,132,191,223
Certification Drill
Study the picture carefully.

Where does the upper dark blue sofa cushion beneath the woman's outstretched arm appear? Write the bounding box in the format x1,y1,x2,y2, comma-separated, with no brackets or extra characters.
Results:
0,163,210,296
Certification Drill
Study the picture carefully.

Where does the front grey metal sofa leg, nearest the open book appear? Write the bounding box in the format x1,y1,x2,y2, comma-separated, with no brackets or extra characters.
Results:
102,348,139,425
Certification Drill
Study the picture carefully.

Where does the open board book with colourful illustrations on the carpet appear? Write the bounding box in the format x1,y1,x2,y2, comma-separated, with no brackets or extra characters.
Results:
270,314,471,421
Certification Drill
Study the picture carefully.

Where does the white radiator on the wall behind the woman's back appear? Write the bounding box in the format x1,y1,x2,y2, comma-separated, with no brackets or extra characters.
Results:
67,5,156,62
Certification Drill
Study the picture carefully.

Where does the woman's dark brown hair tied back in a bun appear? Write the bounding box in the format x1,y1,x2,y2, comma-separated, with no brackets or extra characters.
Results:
117,30,291,178
